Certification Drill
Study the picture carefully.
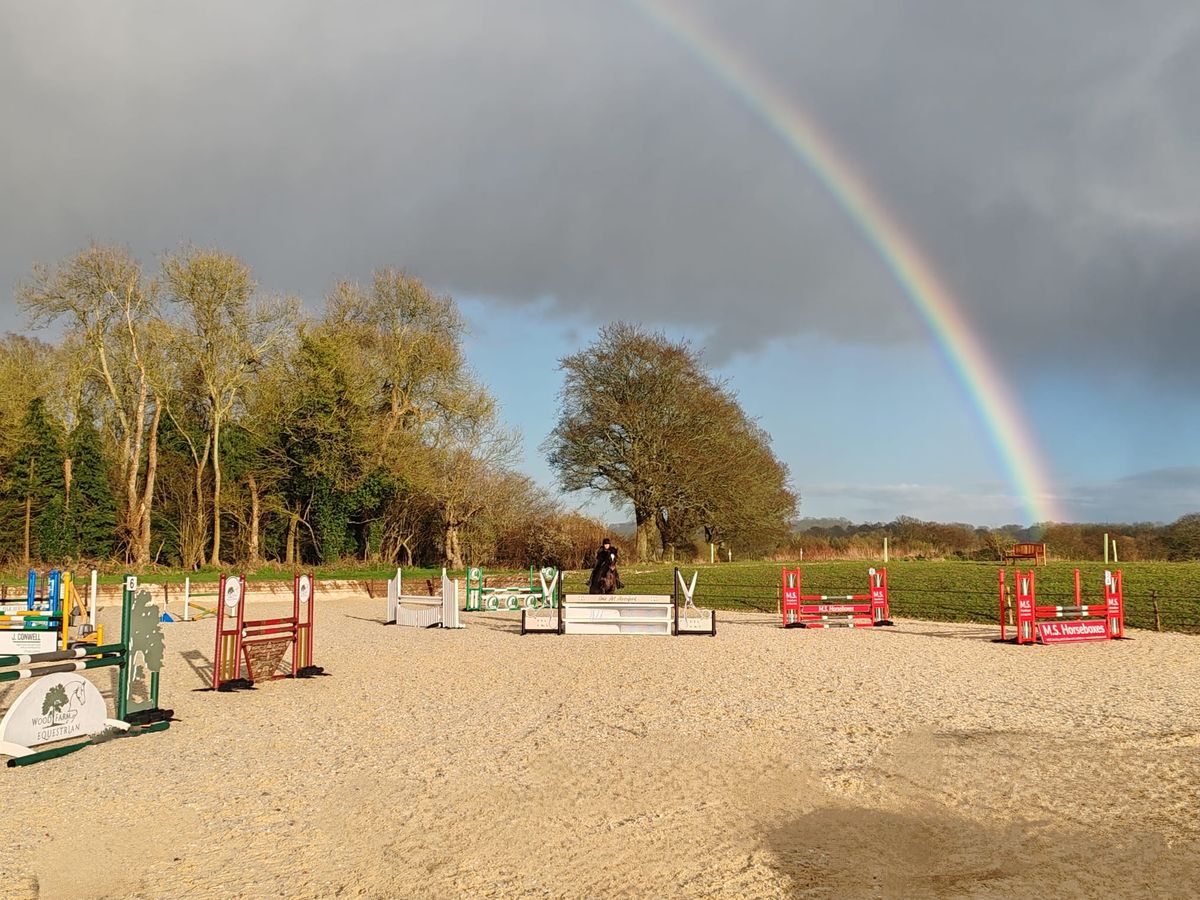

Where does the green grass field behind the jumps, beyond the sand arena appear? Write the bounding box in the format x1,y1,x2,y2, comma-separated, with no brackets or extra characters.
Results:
0,560,1200,632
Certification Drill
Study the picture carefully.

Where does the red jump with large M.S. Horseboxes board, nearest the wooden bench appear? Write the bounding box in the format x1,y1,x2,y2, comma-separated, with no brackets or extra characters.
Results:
1000,569,1124,644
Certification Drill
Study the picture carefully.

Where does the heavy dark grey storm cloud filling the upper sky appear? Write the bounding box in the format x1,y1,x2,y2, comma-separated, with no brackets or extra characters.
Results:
0,0,1200,378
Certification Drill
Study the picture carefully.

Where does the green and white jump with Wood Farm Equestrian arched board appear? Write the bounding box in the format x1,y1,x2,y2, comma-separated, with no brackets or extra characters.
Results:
0,576,172,766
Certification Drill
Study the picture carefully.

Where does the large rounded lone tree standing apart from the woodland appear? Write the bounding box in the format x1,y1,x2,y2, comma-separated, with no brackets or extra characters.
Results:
544,323,797,559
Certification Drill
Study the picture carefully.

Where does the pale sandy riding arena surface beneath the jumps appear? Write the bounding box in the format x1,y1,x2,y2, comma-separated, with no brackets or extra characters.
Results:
0,598,1200,898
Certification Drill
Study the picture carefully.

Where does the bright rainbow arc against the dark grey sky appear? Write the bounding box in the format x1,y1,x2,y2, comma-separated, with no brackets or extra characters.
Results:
628,0,1060,522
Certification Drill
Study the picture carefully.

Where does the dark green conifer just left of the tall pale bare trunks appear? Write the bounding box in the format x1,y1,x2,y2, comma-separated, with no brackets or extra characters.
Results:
66,416,116,559
